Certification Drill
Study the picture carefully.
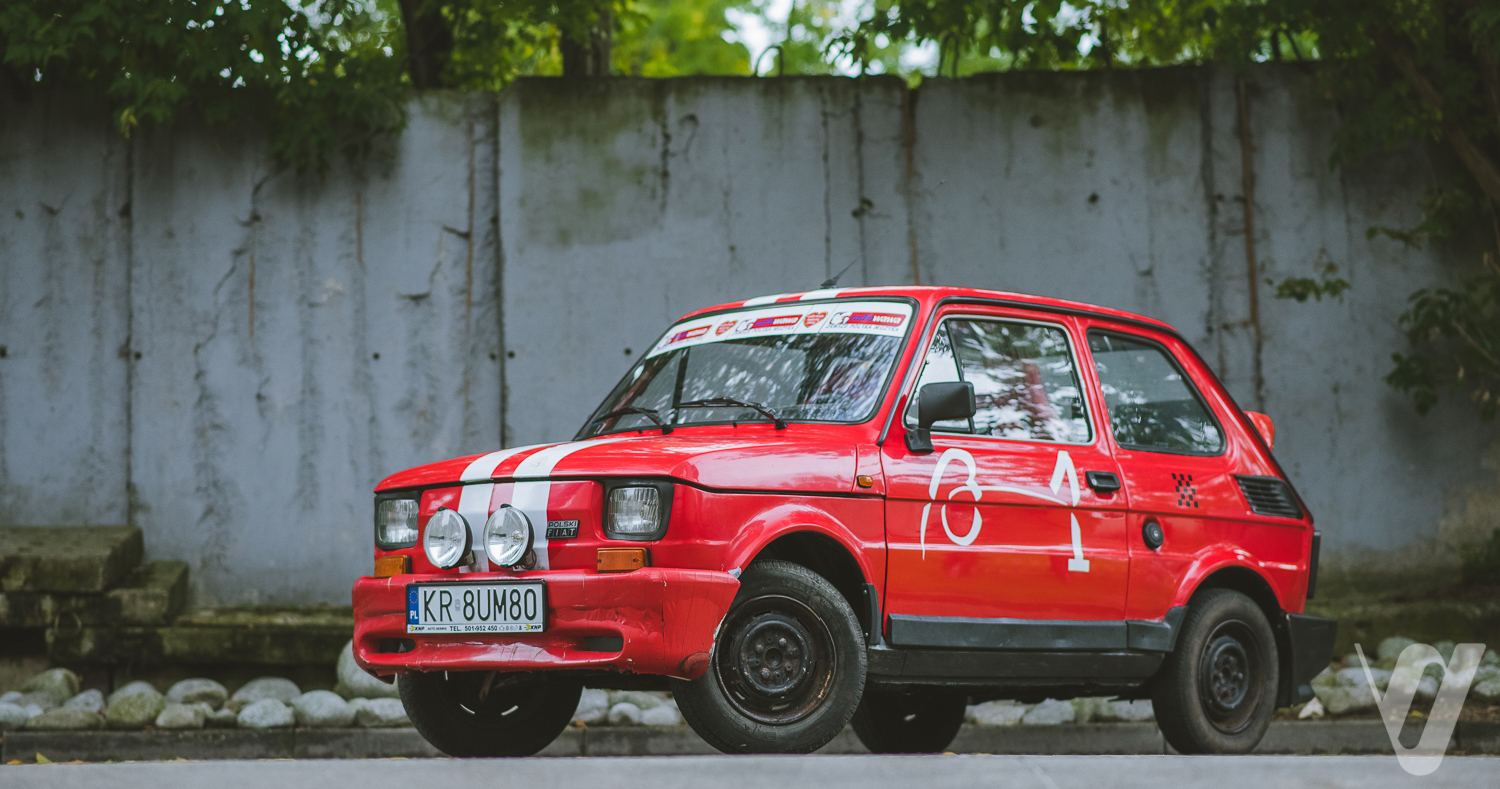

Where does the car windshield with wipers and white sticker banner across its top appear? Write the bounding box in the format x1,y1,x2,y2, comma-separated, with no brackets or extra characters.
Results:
578,302,912,438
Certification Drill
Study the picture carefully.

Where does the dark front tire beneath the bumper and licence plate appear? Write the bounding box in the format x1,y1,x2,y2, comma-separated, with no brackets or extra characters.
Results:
398,671,584,756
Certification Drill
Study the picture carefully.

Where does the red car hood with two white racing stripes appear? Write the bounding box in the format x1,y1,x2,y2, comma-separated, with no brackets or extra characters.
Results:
377,425,857,494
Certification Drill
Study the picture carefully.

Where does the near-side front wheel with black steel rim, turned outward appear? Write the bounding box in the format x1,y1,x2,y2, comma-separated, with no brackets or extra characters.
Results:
672,561,866,753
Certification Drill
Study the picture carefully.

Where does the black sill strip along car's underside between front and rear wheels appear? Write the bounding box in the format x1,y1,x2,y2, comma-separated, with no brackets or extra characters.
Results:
866,648,1164,683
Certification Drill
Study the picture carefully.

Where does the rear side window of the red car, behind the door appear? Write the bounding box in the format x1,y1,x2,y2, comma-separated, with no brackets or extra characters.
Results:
1089,332,1224,455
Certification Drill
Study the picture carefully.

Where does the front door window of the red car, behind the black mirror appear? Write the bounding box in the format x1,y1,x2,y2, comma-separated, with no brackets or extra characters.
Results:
908,318,1091,444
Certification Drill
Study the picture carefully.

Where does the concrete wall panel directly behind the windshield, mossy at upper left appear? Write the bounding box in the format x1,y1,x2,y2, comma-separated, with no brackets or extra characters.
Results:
500,78,906,446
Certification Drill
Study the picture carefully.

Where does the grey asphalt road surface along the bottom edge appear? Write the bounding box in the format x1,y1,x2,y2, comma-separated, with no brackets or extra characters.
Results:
0,756,1500,789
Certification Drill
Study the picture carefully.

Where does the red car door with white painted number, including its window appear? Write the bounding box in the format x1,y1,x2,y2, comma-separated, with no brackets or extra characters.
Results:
882,308,1128,647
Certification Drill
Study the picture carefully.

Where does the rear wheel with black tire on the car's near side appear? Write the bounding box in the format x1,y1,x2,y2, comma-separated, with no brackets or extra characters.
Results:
1151,590,1280,753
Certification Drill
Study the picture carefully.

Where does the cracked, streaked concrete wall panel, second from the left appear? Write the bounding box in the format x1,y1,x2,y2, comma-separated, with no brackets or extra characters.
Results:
132,96,500,605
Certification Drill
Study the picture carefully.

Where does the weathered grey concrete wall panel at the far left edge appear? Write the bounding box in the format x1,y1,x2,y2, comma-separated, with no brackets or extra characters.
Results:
0,92,131,525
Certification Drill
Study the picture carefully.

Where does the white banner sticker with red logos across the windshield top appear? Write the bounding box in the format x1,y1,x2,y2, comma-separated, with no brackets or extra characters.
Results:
647,302,912,359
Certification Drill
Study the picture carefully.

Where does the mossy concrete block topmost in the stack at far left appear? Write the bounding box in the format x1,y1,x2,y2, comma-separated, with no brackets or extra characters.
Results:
0,527,144,593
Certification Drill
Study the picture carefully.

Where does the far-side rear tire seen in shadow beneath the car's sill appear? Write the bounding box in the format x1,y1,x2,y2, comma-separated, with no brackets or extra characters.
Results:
851,689,968,753
